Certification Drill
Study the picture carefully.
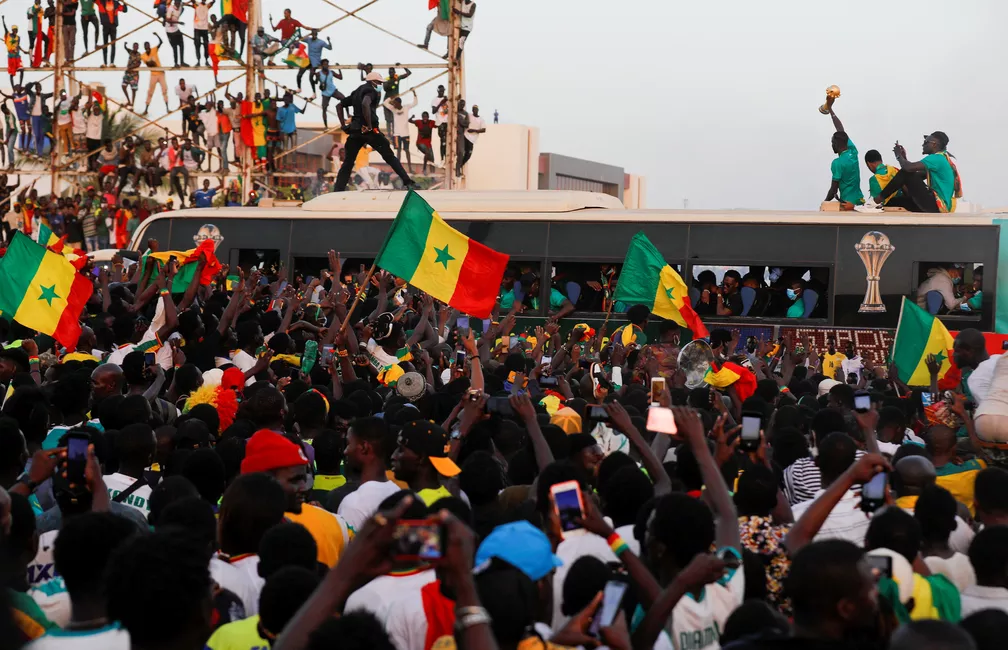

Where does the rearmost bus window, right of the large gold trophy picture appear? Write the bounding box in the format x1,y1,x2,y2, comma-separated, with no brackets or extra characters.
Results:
910,262,984,316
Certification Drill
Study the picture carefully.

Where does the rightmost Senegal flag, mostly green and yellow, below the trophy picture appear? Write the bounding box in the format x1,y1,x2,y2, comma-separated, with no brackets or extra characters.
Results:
892,298,953,386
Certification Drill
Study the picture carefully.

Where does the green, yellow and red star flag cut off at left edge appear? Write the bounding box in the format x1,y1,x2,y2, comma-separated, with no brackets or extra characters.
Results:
0,233,94,350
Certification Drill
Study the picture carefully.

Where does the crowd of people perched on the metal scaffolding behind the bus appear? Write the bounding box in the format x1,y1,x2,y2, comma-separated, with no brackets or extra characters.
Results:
0,0,486,203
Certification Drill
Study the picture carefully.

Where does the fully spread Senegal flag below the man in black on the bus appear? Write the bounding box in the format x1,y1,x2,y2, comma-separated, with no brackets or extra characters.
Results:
375,190,508,318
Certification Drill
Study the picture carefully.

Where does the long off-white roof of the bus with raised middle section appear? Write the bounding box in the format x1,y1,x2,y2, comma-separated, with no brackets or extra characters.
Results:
145,190,1008,227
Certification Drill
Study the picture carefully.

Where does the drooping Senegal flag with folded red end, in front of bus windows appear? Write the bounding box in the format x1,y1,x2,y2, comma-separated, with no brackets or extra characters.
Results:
613,232,711,339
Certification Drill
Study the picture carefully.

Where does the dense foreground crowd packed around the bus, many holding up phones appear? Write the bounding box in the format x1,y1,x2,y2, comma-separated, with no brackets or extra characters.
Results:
0,240,1008,650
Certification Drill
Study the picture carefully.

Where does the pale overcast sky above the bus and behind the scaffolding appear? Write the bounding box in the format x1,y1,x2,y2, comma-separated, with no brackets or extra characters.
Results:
27,0,1008,210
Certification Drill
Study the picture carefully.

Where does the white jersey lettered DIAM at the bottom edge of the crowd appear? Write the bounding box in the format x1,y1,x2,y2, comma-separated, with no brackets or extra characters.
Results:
669,552,746,650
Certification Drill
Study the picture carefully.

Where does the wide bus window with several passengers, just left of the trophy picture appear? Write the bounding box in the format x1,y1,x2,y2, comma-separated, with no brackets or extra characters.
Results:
689,265,830,318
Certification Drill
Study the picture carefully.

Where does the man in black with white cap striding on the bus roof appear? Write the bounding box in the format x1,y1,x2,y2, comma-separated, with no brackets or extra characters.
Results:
335,72,416,191
